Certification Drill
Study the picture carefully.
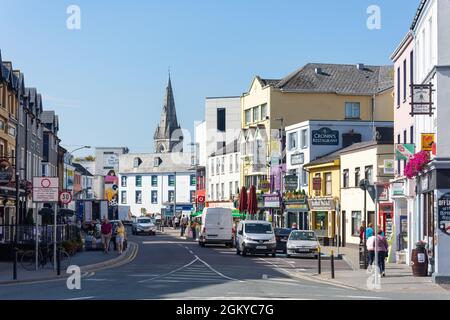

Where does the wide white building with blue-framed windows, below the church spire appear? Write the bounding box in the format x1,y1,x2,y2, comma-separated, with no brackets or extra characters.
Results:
119,152,196,217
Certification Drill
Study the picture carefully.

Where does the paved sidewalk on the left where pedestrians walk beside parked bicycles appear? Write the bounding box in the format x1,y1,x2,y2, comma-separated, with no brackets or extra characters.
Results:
0,242,138,285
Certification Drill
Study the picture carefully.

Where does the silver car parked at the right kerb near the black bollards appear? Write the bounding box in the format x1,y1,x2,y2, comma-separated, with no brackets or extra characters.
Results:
287,230,320,258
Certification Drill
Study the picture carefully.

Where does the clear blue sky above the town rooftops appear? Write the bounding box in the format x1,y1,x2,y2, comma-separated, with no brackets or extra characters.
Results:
0,0,420,155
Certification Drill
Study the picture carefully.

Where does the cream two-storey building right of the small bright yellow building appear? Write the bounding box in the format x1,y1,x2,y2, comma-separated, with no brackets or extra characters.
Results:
339,141,394,244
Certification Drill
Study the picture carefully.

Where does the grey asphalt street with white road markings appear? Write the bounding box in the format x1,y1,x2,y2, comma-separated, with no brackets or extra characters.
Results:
0,228,450,300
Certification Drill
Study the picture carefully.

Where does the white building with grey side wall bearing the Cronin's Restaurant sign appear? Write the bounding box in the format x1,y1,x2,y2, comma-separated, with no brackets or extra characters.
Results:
286,120,394,192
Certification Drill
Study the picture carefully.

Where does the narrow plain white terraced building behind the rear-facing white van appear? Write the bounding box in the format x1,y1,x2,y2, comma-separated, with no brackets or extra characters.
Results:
206,141,241,202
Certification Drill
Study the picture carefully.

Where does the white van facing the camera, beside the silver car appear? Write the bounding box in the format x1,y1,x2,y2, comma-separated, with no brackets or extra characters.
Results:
236,220,277,257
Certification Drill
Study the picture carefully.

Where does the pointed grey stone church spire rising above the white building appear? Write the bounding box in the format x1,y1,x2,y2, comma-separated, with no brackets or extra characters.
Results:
153,74,183,153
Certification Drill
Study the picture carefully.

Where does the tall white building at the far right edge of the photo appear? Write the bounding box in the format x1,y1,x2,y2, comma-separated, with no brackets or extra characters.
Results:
409,0,450,282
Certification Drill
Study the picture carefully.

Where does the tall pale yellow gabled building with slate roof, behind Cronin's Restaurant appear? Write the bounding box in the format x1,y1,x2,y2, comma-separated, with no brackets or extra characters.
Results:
240,64,394,195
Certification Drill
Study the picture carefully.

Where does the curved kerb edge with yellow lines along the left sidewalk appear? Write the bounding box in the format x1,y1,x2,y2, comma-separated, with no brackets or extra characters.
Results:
0,242,139,286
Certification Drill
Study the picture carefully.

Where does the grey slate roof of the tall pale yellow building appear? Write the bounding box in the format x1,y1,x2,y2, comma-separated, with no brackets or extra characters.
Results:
275,63,394,95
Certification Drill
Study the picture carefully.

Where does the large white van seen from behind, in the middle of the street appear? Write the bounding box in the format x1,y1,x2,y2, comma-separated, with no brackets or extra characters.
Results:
198,208,233,247
